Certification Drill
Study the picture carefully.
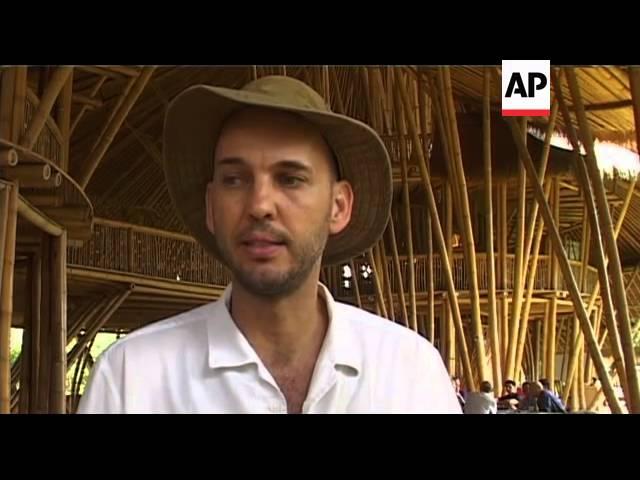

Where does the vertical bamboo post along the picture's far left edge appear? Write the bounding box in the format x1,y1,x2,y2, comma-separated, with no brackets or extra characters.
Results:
0,185,18,413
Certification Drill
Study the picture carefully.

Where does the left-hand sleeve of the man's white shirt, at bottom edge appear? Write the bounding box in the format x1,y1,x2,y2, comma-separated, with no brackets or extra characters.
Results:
77,352,124,414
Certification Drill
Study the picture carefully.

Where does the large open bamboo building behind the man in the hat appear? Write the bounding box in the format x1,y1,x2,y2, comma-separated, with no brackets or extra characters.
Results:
0,66,640,413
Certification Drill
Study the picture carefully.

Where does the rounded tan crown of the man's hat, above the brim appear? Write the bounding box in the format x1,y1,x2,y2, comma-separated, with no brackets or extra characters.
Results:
242,75,331,112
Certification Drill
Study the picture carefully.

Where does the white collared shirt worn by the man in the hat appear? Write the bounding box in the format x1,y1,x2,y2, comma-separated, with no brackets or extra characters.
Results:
78,285,461,413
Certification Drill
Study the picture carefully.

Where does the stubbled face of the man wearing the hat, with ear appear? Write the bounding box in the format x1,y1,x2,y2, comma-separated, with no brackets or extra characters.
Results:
206,109,353,297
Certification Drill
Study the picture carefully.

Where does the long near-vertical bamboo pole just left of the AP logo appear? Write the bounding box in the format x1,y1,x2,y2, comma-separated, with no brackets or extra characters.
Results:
482,69,502,388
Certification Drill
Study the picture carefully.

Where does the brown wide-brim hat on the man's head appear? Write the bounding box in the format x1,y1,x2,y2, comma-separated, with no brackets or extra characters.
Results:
163,76,392,264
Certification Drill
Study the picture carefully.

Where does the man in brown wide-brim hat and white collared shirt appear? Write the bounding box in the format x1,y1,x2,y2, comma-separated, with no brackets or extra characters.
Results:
79,77,460,413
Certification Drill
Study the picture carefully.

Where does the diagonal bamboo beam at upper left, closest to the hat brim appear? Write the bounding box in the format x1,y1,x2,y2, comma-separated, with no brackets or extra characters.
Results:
79,67,155,188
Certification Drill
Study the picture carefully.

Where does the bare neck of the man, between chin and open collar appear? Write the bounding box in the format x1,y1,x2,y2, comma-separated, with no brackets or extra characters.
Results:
231,275,328,367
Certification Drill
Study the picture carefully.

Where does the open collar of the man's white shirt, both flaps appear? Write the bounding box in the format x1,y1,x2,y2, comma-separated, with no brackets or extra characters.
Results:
207,283,362,373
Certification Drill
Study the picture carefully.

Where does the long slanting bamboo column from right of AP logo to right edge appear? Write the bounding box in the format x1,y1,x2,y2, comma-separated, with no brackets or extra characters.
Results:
567,68,640,413
